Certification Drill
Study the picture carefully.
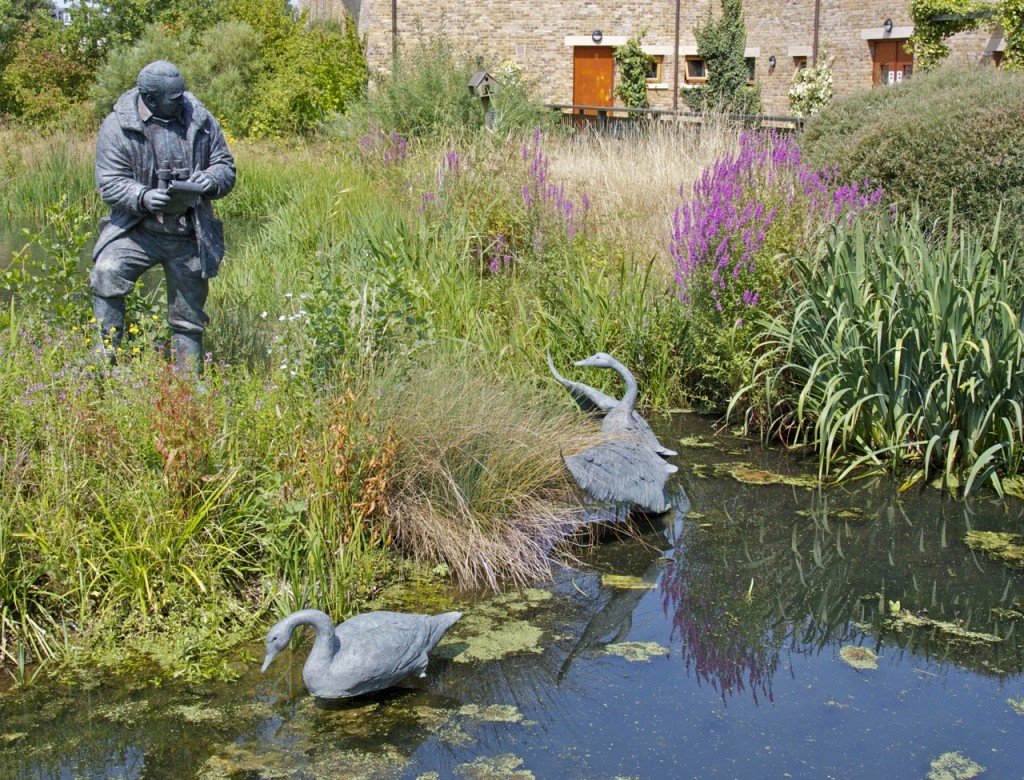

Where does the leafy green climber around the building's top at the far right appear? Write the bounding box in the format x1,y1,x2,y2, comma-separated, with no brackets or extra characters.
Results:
907,0,1024,71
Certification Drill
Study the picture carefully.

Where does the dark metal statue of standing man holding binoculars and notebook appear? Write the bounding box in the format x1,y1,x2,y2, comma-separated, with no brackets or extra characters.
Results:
89,60,236,373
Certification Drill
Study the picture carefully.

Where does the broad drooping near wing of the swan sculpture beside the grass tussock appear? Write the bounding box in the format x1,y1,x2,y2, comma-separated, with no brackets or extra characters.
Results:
564,439,677,514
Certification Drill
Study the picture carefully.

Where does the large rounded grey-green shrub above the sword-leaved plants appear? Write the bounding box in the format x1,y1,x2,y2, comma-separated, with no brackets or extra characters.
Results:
801,66,1024,234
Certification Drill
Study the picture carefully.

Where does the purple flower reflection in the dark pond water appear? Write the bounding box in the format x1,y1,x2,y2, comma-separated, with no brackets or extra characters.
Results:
659,532,790,701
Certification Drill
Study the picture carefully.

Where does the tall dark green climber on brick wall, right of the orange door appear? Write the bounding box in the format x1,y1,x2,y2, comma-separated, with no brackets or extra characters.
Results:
682,0,761,114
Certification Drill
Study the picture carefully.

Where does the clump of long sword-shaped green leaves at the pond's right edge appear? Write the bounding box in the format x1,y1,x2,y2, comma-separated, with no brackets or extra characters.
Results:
733,209,1024,493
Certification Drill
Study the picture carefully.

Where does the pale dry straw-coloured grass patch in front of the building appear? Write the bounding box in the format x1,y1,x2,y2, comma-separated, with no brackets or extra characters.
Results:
545,121,742,272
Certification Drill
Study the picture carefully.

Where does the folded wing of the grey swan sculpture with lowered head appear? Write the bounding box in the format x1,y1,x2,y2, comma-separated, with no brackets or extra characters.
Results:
331,611,432,696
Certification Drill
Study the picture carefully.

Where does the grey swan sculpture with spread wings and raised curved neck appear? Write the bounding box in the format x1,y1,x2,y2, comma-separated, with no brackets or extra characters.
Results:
548,352,678,514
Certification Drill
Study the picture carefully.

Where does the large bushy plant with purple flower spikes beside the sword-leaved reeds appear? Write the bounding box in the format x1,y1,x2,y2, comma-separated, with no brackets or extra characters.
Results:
670,133,882,405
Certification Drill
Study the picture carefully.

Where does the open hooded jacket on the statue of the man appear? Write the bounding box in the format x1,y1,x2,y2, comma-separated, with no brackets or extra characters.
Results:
92,88,234,278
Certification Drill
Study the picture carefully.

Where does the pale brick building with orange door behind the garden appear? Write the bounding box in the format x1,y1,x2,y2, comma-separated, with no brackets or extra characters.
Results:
300,0,1005,115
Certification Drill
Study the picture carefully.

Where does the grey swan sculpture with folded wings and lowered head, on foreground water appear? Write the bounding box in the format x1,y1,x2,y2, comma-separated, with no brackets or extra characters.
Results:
260,609,462,699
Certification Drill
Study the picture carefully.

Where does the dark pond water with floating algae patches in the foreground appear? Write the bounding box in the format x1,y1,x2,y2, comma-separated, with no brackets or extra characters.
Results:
0,417,1024,780
